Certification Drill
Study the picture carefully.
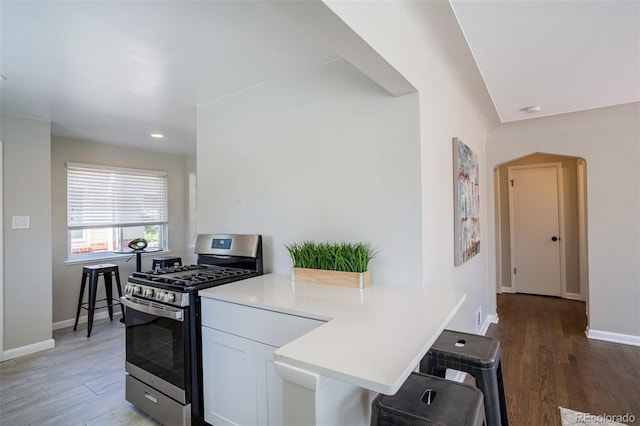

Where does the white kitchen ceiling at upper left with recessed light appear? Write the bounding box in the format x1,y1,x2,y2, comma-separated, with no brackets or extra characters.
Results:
0,0,338,153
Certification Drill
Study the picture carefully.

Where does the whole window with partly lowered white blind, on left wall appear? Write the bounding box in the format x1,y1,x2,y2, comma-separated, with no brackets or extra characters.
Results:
67,163,168,260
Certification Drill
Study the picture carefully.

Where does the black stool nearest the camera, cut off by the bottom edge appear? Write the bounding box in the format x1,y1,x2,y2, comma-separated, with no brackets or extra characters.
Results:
371,373,486,426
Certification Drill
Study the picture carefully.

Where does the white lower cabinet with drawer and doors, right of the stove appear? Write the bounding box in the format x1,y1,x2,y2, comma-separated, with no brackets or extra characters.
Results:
202,298,324,426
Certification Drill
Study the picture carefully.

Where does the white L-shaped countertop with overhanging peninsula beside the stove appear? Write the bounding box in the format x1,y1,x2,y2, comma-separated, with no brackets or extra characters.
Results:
200,274,465,395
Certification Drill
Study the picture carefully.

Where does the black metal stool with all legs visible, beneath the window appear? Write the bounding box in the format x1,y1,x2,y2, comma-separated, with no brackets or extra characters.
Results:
73,263,124,337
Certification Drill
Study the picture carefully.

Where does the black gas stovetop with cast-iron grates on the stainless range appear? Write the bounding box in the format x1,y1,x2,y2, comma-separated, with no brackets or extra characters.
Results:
129,265,256,292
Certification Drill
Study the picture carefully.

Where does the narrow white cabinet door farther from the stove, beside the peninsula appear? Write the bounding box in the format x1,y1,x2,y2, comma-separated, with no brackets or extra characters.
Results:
255,343,282,426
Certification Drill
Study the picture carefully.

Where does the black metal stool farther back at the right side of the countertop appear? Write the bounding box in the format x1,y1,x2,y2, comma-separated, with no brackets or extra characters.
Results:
420,330,509,426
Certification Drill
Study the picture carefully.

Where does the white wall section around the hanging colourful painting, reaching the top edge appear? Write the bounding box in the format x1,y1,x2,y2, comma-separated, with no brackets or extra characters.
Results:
325,1,498,332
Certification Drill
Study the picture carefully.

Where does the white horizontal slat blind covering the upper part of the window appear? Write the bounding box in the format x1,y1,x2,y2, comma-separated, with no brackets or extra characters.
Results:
67,163,167,230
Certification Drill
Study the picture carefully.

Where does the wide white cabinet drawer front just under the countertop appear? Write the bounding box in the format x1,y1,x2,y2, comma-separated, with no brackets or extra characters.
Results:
201,297,325,348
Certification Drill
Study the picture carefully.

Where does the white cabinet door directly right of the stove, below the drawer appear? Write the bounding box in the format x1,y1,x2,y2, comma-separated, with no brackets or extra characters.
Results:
202,327,259,426
